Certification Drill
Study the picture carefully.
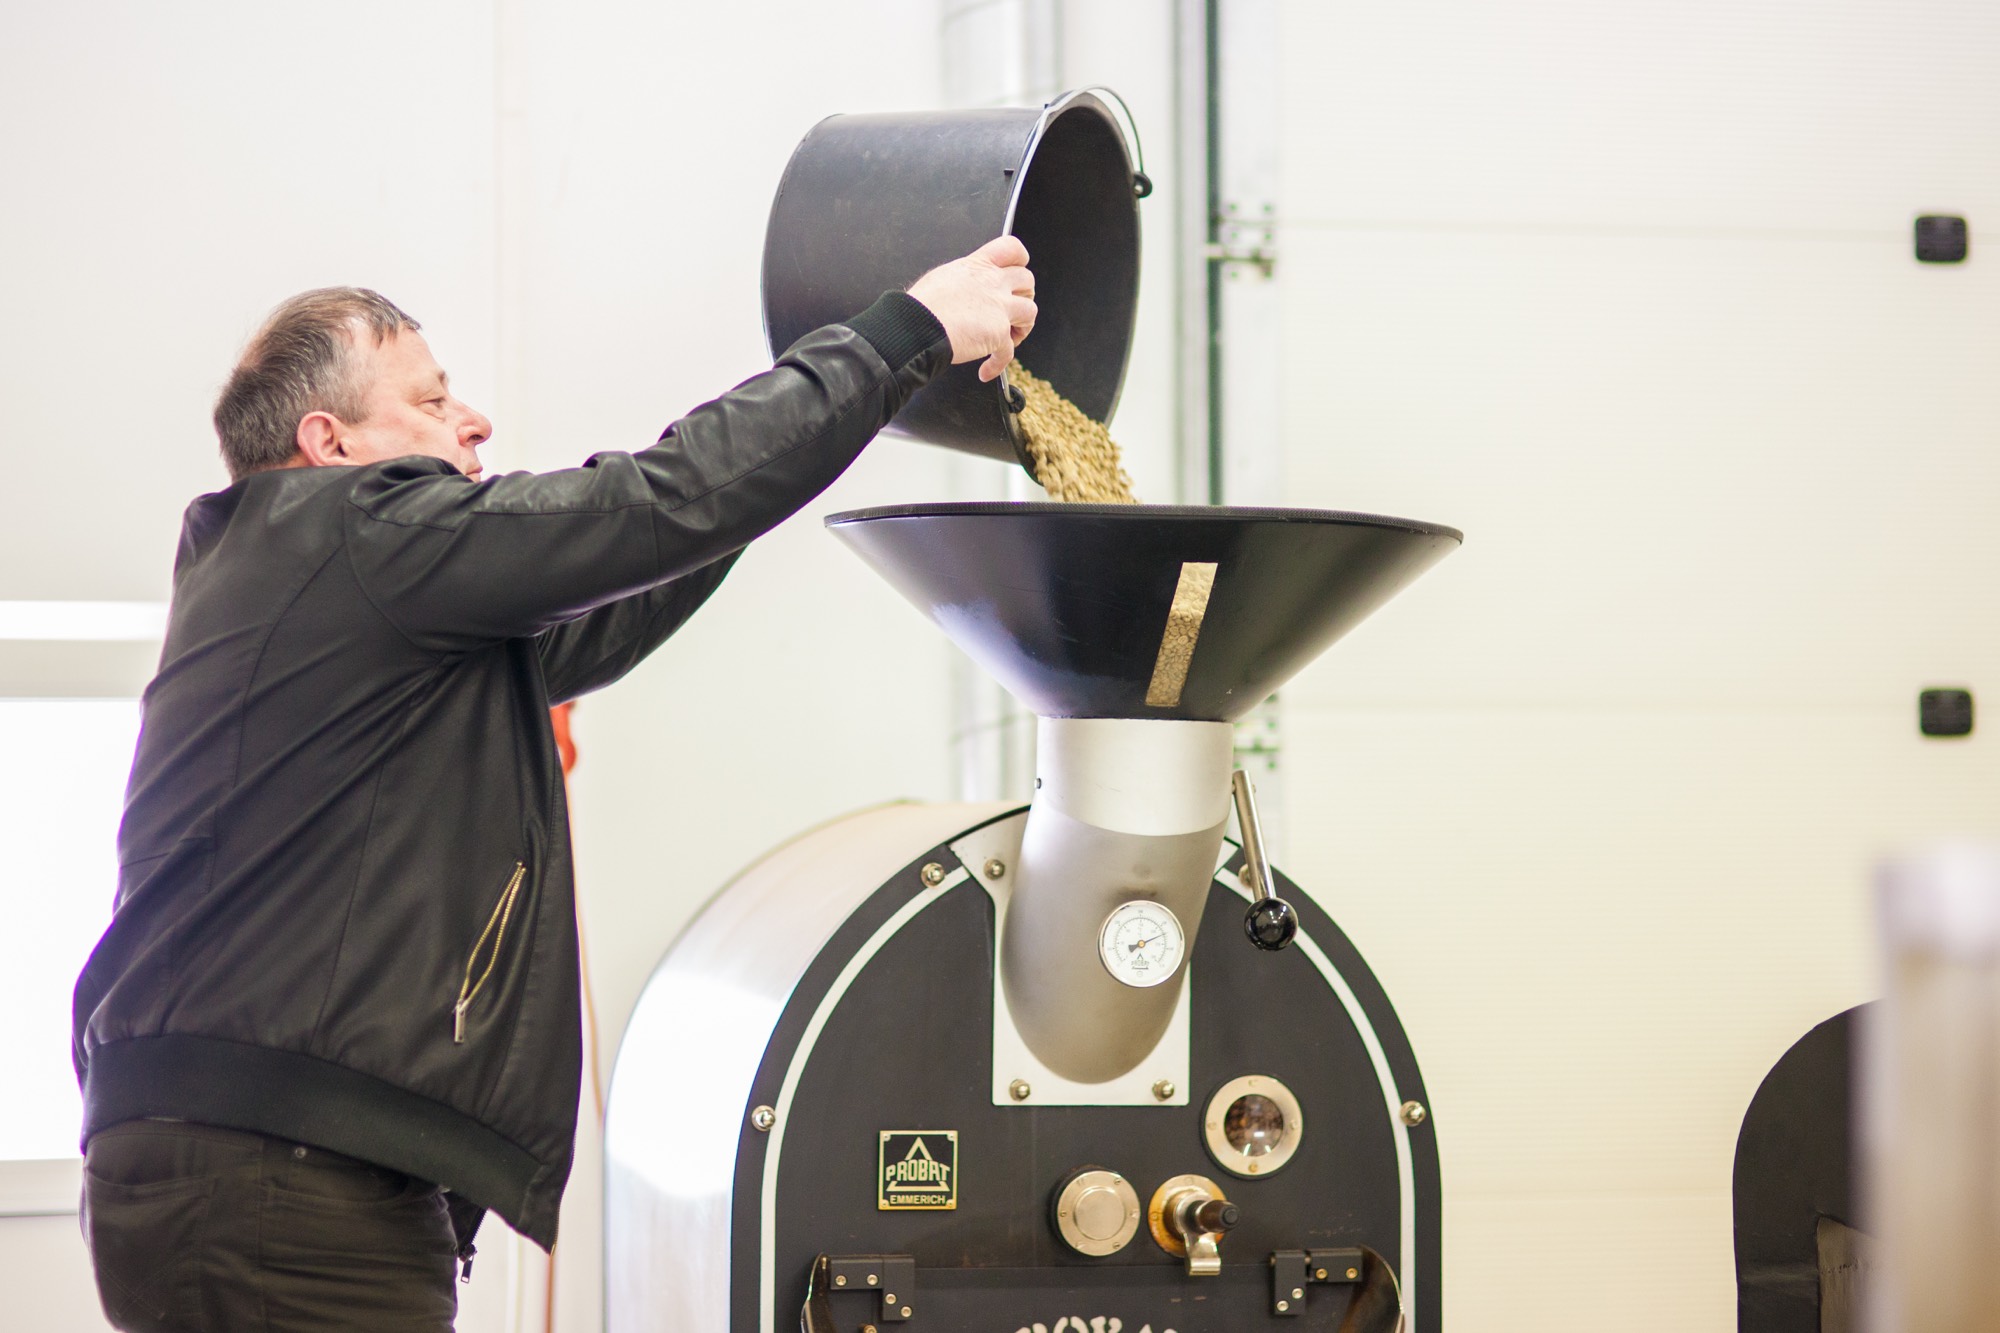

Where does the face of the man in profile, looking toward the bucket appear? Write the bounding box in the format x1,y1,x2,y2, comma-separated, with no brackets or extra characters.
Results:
326,328,494,480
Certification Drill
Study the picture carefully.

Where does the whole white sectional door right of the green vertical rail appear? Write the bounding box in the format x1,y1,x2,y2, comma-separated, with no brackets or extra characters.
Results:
1278,0,2000,1333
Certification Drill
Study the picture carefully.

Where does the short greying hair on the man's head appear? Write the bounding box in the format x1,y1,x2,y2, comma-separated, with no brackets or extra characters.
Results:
216,286,422,480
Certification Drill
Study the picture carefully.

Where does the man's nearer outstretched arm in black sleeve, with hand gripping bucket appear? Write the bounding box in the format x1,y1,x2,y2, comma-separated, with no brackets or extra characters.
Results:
348,238,1034,652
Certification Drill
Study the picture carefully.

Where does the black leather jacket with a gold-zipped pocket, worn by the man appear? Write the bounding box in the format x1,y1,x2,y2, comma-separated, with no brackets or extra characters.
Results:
74,294,950,1247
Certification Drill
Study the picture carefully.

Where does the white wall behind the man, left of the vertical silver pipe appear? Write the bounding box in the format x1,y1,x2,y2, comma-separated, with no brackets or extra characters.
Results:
0,0,948,1331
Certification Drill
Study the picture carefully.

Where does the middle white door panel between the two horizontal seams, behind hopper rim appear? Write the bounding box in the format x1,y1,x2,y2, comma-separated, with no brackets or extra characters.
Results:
1284,226,2000,711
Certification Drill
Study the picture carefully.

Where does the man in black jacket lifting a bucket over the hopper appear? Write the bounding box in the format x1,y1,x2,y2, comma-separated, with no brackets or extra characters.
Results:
76,236,1036,1331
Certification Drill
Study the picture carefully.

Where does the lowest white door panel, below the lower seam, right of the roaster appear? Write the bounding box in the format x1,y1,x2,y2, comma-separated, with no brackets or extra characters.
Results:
1288,707,2000,1333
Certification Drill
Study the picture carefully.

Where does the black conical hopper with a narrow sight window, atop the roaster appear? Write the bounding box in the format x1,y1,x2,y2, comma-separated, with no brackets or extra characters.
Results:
826,504,1462,723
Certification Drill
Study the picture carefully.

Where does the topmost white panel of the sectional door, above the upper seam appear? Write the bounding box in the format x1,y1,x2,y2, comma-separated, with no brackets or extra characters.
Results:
1276,0,2000,236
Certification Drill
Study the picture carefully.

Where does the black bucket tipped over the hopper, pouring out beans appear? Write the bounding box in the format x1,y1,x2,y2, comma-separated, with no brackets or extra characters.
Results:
764,92,1150,472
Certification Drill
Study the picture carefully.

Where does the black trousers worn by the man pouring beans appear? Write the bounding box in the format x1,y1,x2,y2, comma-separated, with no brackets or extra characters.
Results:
82,1121,458,1333
